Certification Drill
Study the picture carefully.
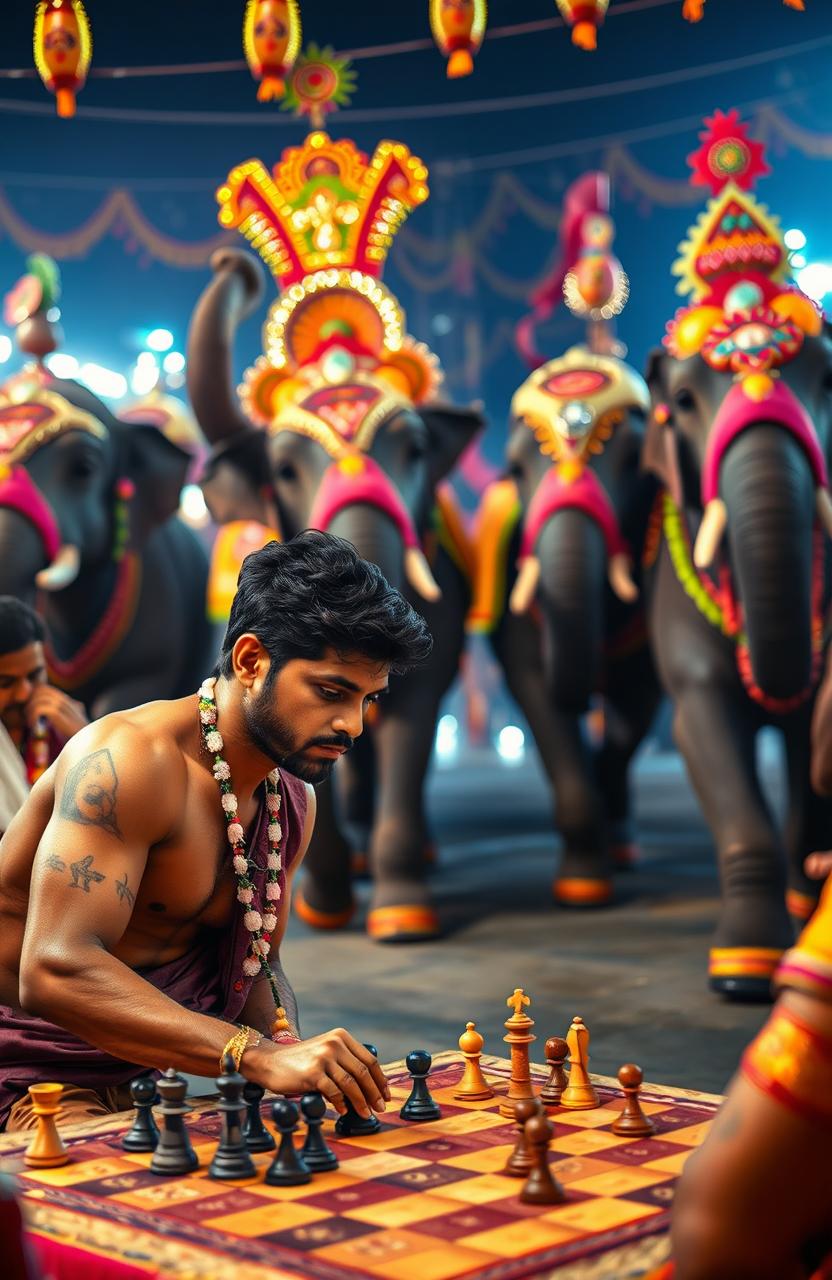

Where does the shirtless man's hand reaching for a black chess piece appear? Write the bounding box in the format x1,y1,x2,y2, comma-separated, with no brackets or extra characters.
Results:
243,1027,390,1117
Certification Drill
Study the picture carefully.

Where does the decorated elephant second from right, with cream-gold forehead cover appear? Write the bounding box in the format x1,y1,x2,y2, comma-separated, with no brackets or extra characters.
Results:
470,347,659,906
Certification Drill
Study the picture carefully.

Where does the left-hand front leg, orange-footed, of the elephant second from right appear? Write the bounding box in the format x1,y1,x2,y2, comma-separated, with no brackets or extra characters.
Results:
494,616,612,908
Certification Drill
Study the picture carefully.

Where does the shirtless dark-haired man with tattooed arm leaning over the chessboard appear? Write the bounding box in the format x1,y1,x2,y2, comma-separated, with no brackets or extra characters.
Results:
0,532,431,1129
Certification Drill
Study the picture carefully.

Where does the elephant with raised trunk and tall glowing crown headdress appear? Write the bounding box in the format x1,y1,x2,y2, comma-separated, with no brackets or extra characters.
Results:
188,132,483,942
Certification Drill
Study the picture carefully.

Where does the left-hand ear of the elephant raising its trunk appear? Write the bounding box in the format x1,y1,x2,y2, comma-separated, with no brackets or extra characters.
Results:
200,426,275,527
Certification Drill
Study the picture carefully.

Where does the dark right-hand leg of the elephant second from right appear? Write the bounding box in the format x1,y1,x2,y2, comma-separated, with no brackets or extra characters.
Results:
595,649,660,867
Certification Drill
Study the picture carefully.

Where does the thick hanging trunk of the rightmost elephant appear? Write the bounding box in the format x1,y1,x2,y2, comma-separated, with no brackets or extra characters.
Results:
719,422,817,699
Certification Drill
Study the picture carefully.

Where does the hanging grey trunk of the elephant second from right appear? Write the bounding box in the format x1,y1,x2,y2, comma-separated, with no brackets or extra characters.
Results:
538,508,607,714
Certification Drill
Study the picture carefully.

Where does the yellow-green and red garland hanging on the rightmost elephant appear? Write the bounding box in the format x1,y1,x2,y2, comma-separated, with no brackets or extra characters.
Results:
662,493,823,716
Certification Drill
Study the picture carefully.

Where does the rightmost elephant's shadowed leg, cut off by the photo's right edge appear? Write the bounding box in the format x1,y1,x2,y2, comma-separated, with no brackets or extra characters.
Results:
785,712,832,928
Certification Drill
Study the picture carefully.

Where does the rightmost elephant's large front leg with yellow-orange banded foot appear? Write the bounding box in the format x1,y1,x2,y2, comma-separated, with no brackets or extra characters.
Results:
673,684,794,1000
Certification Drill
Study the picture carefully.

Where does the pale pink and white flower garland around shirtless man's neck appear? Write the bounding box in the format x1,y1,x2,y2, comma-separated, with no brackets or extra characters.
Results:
198,677,288,1013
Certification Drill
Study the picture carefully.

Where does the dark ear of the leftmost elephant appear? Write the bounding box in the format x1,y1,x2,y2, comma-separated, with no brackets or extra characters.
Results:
115,422,192,544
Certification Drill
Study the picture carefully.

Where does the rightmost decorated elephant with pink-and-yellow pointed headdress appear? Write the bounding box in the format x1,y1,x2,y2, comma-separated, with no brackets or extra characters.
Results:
644,113,832,998
